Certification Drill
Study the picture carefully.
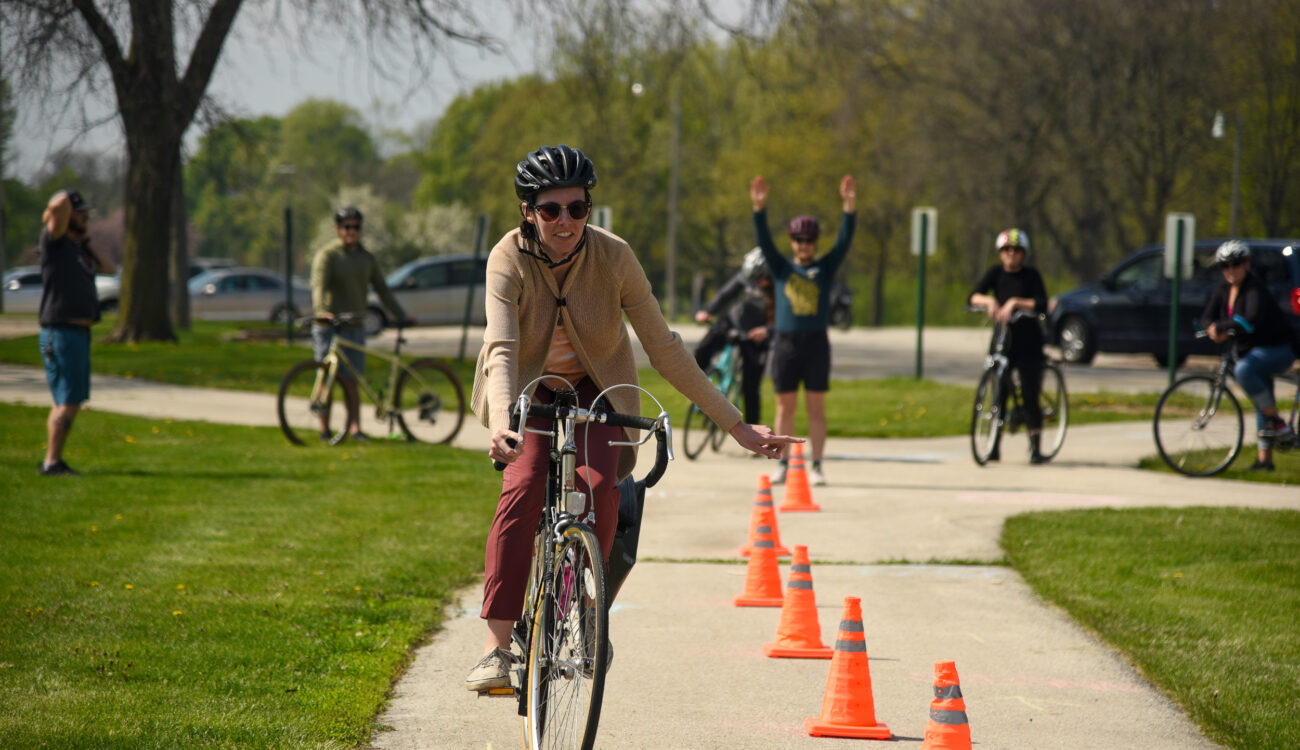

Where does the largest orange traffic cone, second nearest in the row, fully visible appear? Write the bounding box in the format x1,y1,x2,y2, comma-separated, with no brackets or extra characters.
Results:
803,597,893,740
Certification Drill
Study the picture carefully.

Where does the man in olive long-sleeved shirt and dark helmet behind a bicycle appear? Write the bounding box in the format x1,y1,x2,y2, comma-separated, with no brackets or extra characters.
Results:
312,205,407,442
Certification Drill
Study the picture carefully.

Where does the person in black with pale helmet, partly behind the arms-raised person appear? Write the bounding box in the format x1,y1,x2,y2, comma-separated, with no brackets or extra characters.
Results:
696,247,775,424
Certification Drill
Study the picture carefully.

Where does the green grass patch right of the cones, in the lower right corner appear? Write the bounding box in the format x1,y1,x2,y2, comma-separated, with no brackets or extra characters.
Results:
1002,508,1300,750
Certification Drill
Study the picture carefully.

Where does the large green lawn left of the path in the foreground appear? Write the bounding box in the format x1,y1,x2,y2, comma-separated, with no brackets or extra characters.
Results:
0,404,501,749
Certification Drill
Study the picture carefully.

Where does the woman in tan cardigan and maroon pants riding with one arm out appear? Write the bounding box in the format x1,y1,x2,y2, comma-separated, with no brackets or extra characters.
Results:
465,146,797,692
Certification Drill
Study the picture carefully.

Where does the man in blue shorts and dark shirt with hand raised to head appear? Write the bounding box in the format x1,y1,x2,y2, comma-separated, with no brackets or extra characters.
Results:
38,190,117,477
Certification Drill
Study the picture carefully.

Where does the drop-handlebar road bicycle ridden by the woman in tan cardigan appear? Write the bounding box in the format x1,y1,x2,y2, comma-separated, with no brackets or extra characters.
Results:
489,376,673,750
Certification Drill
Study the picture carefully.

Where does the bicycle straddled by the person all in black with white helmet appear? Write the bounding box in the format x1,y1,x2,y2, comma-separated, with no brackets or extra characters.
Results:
967,307,1070,467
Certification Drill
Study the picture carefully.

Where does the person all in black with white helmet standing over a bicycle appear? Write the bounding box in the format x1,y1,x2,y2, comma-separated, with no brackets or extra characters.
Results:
969,229,1052,464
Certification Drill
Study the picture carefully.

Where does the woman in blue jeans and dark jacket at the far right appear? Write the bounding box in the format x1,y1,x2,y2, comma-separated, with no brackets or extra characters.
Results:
1201,239,1295,471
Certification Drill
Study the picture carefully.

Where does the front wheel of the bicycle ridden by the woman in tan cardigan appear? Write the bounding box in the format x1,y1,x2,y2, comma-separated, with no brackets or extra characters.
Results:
528,524,610,750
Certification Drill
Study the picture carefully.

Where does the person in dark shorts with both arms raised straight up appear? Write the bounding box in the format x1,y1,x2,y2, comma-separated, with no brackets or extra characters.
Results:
749,174,858,485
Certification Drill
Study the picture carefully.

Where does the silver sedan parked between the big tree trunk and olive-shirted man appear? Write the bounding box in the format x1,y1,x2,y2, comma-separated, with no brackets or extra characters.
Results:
190,268,312,322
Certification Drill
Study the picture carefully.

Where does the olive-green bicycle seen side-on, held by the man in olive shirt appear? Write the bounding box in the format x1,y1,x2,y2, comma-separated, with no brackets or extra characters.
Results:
276,313,465,446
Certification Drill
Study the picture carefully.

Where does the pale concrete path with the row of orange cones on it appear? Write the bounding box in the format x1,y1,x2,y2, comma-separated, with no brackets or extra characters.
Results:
0,318,1300,750
